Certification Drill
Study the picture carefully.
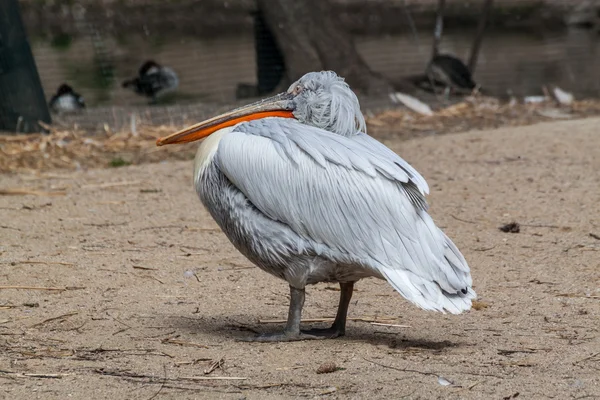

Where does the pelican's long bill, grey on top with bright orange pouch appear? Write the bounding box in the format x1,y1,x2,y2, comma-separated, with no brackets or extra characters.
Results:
156,93,294,146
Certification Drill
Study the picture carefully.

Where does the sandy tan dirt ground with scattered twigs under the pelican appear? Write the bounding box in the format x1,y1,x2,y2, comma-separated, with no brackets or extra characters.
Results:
0,118,600,399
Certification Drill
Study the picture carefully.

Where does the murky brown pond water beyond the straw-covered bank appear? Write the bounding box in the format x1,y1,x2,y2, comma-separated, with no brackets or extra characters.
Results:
32,29,600,106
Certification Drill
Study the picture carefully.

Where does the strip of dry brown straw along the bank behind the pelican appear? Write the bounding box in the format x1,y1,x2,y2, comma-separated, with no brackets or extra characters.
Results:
0,97,600,172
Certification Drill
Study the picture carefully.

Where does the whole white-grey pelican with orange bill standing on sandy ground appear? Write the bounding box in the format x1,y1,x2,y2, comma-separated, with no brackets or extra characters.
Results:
157,71,476,341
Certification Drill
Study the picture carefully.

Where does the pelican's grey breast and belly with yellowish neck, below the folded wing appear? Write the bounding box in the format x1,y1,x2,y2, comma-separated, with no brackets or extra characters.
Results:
194,126,383,288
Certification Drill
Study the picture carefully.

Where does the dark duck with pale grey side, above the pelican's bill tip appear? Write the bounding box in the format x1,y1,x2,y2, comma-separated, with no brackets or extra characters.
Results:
123,60,179,104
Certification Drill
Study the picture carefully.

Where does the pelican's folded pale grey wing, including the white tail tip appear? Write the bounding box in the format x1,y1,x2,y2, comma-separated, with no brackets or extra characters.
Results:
215,118,475,313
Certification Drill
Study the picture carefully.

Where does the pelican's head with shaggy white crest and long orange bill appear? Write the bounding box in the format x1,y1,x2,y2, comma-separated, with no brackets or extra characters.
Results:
156,71,366,146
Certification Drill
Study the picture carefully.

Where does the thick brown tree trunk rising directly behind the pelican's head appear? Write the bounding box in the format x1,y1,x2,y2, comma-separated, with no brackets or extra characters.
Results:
258,0,392,95
